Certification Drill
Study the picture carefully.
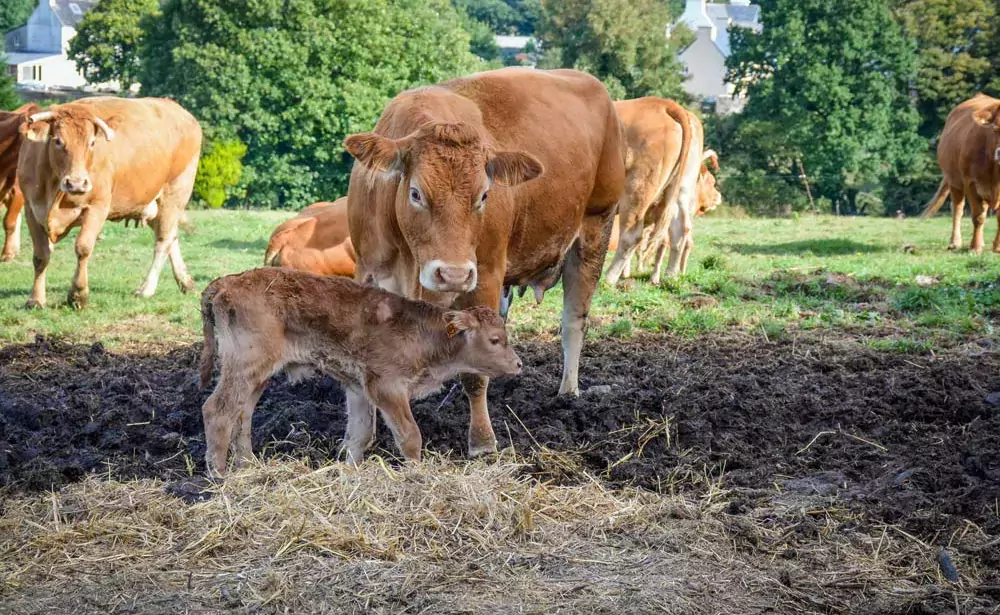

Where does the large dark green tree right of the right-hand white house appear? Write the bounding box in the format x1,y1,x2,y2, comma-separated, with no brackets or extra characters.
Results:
727,0,927,212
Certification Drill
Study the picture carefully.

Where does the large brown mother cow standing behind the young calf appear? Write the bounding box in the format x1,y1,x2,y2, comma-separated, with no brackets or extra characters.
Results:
345,67,625,456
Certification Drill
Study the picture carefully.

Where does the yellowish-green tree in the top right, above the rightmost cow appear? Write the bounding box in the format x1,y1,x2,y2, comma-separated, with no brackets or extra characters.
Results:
892,0,997,138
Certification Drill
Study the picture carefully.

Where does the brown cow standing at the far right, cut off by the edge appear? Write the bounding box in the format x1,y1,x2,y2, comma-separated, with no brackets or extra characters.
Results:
923,94,1000,254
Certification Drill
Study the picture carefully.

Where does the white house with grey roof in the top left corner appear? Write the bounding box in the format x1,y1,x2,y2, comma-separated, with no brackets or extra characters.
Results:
0,0,98,88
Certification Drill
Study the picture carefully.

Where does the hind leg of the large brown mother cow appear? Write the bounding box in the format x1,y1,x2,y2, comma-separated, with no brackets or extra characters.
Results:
559,208,614,395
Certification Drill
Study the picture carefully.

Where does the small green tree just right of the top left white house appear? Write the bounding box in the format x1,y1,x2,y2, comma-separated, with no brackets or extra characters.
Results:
69,0,160,90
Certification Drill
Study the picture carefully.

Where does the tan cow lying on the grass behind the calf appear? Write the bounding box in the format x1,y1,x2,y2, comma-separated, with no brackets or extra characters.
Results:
264,197,358,278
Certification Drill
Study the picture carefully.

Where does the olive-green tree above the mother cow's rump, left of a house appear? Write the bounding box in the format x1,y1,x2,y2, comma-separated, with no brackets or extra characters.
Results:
539,0,690,100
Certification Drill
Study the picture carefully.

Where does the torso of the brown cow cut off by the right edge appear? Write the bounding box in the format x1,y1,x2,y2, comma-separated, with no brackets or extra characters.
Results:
938,94,1000,186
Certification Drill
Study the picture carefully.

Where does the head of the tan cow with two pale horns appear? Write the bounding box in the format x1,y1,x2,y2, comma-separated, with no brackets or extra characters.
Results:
21,105,115,195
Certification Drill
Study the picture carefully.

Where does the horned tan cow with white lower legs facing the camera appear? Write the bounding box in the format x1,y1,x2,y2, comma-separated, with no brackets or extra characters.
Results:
18,97,201,307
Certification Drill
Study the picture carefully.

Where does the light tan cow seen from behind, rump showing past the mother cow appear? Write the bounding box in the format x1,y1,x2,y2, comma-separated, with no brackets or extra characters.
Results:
606,96,704,286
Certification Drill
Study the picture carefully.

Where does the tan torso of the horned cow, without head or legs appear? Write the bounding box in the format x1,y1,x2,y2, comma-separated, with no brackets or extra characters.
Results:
75,96,202,211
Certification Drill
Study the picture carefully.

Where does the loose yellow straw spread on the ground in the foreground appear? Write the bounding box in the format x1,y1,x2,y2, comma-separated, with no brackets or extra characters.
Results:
0,454,992,613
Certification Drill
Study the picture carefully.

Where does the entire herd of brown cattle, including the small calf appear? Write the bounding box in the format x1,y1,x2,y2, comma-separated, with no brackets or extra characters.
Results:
0,68,1000,474
